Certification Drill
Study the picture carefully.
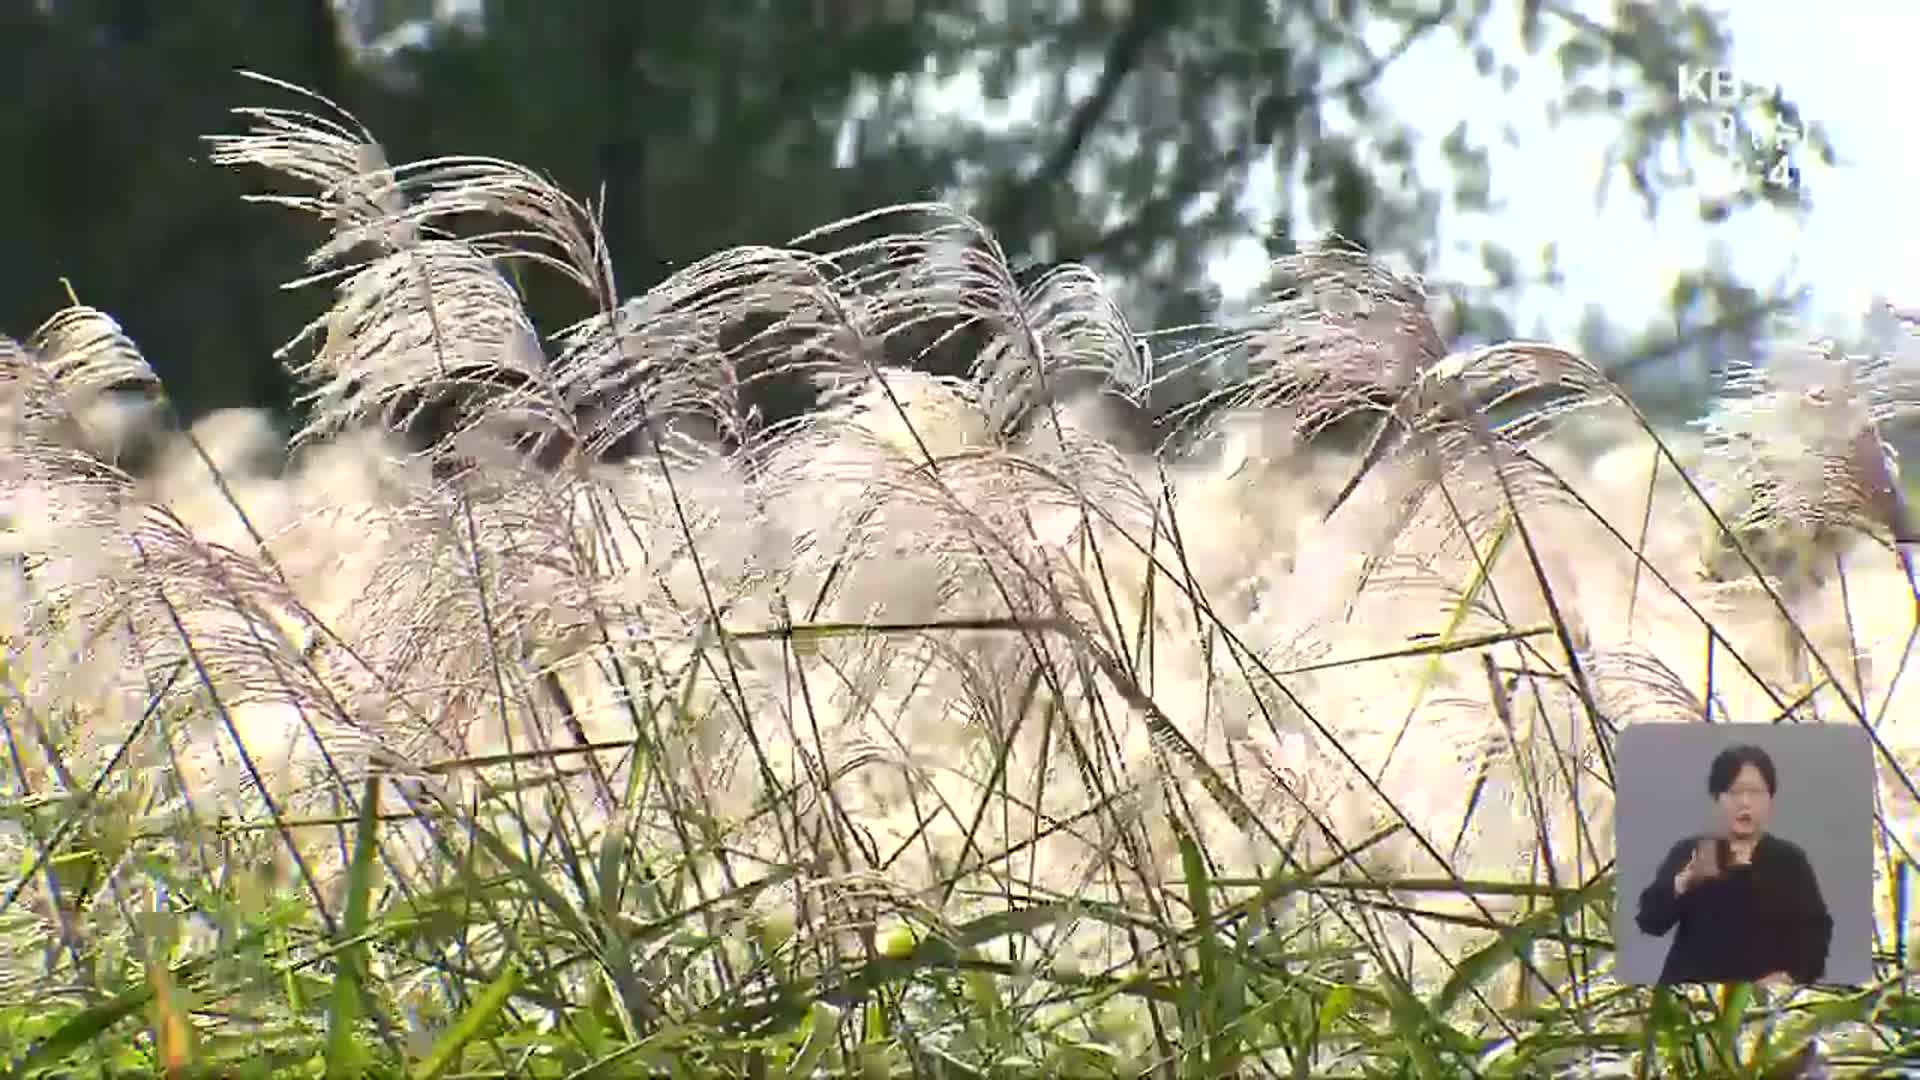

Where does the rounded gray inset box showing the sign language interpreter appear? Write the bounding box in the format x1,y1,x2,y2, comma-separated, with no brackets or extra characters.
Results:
1613,723,1874,986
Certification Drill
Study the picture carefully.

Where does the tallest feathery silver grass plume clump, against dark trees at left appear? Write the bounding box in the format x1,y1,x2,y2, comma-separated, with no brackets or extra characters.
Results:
209,71,587,466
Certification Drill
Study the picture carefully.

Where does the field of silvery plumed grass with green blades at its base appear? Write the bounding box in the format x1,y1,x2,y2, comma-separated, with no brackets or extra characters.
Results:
0,71,1920,1078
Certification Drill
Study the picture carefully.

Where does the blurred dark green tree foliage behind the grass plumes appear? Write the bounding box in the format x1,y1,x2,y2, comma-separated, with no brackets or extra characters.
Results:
0,0,1820,428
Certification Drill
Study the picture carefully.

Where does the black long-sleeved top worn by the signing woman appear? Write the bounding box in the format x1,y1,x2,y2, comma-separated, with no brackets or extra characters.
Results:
1636,834,1834,984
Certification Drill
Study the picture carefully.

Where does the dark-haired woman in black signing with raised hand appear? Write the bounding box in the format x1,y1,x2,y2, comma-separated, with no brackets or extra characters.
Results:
1636,746,1834,986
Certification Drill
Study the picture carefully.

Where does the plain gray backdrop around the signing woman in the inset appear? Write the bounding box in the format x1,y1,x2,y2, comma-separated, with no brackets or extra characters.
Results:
1613,724,1874,986
